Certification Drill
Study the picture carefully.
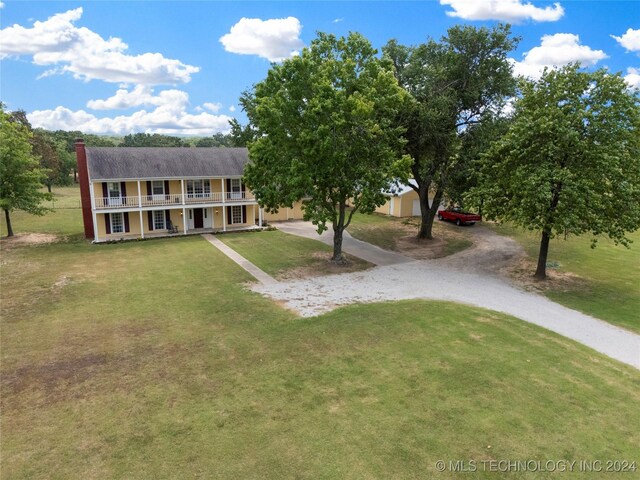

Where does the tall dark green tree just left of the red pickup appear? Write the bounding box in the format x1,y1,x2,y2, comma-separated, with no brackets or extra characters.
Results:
383,25,517,239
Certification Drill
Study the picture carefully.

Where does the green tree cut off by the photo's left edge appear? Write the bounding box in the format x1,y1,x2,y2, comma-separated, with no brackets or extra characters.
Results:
0,104,51,237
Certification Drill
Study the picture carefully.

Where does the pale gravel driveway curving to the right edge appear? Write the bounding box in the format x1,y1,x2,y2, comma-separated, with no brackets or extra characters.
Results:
252,222,640,369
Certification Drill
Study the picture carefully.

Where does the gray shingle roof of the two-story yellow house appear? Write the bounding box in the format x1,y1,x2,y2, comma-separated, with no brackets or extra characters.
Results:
86,147,249,180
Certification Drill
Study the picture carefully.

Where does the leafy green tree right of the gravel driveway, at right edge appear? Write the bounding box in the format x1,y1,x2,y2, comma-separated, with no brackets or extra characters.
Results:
476,65,640,279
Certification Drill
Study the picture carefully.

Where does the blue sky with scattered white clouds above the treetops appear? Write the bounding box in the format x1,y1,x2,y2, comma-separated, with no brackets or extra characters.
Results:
0,0,640,135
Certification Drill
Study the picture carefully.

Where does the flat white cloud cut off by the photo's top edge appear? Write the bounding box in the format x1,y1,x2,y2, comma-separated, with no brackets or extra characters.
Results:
440,0,564,23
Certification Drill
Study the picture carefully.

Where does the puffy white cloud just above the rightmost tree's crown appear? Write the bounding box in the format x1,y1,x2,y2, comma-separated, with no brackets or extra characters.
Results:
510,33,608,79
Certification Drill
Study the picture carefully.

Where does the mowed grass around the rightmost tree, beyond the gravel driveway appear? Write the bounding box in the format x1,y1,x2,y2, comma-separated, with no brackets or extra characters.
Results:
492,225,640,333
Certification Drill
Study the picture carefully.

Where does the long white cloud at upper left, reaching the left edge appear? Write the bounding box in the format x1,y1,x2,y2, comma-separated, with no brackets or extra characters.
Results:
0,8,200,85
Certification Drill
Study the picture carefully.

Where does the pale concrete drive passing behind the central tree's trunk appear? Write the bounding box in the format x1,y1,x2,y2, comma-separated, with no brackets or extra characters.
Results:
273,221,415,266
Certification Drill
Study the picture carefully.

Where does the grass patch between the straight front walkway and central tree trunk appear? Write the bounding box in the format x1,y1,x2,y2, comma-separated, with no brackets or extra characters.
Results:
218,230,373,277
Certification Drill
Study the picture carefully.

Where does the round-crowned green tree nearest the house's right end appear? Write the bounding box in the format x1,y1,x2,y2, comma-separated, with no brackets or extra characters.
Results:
241,33,409,262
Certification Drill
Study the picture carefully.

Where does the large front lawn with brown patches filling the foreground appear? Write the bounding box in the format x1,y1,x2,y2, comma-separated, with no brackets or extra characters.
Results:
0,190,640,479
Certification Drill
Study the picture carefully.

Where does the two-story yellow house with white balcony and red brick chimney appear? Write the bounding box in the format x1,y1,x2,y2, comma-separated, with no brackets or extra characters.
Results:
76,140,302,242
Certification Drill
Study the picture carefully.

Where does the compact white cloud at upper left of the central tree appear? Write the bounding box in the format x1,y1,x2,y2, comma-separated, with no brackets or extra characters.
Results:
220,17,304,62
